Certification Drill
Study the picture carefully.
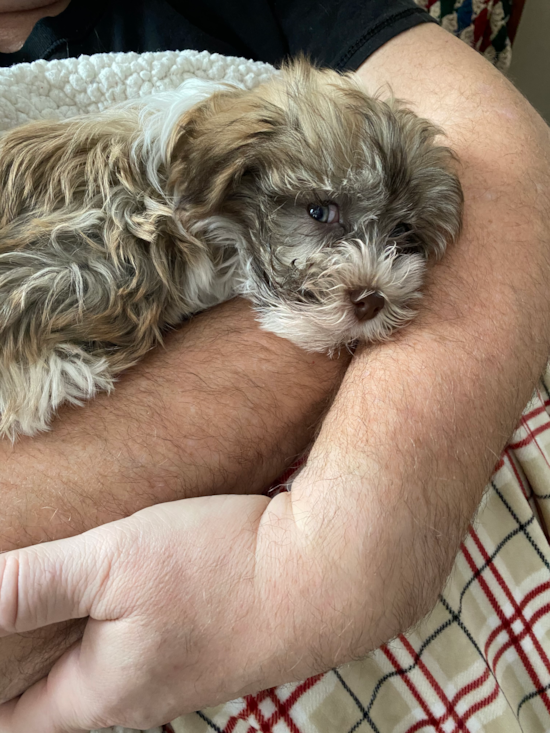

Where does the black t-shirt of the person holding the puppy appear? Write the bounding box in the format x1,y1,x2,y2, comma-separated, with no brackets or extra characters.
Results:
0,0,440,70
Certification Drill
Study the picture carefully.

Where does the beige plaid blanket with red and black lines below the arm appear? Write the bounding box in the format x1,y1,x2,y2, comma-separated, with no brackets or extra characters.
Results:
144,369,550,733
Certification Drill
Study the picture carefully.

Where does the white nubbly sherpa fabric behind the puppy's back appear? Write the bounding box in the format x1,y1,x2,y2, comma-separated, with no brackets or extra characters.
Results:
0,51,274,733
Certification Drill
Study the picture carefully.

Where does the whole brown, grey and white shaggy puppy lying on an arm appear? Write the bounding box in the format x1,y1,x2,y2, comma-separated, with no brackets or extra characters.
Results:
0,60,462,439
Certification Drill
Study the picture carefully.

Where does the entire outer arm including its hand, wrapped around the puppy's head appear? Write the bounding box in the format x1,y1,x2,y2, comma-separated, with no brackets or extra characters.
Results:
0,15,550,733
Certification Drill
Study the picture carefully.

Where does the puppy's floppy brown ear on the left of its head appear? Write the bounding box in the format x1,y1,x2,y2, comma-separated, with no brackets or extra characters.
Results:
168,84,284,217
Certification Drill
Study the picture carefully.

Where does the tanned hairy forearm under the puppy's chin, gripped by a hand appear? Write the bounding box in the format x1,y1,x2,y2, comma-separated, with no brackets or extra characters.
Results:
0,300,346,700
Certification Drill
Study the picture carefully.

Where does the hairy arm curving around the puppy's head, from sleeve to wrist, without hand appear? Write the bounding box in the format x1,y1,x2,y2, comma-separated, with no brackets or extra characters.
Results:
260,26,550,672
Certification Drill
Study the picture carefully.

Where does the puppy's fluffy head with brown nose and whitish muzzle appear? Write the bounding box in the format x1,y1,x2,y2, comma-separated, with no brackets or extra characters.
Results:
170,61,462,351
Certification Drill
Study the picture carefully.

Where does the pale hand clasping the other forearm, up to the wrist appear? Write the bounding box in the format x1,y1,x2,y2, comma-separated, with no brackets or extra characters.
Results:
0,496,306,733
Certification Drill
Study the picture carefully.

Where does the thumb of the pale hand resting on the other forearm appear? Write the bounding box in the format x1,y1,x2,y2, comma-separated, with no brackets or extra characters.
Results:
0,530,116,637
